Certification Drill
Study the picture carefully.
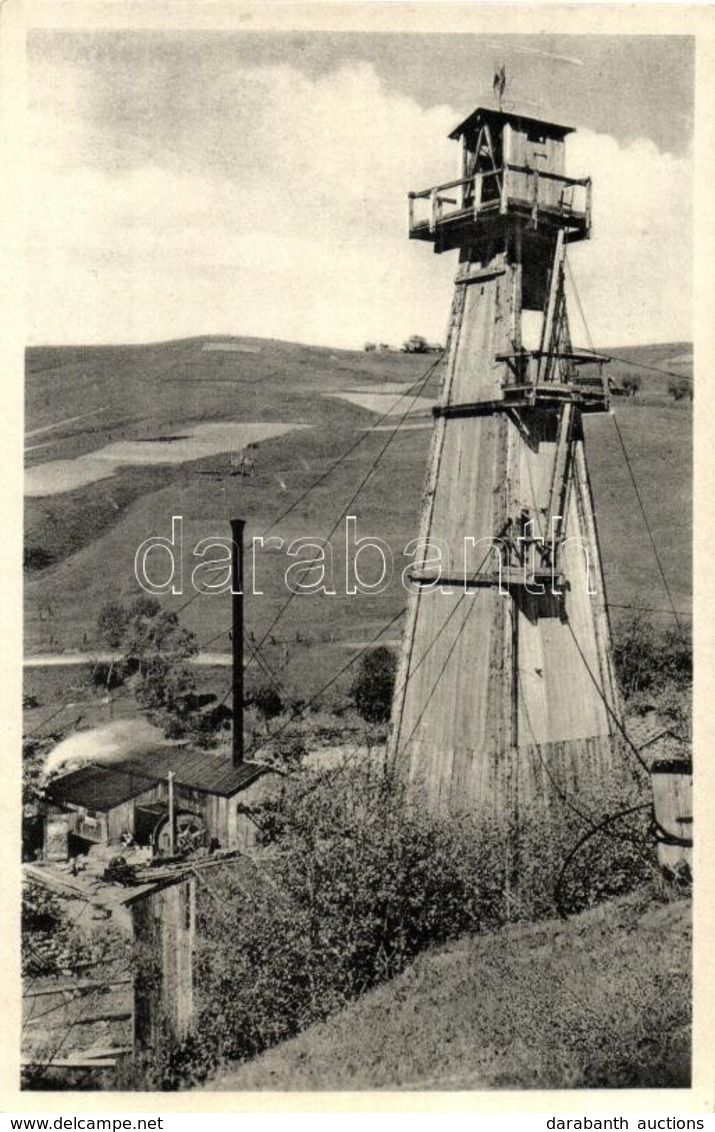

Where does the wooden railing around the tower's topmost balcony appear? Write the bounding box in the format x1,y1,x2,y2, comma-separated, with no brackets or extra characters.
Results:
408,163,592,233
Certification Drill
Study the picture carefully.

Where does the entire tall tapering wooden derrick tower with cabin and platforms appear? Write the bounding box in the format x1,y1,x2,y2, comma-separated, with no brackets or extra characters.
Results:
390,109,621,814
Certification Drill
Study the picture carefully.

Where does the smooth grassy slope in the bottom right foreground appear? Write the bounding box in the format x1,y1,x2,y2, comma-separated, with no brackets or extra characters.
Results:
206,897,690,1091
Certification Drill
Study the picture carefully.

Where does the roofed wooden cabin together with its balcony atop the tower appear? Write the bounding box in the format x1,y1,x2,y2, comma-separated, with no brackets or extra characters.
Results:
410,106,591,310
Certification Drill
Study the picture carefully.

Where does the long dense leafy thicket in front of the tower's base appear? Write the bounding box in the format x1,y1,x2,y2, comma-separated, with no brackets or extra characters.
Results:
149,758,655,1088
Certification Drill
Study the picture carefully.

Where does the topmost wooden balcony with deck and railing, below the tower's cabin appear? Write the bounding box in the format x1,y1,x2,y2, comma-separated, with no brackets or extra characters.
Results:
408,163,591,251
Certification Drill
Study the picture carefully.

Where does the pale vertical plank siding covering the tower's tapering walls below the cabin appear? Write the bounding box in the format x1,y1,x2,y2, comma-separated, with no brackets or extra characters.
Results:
389,232,631,842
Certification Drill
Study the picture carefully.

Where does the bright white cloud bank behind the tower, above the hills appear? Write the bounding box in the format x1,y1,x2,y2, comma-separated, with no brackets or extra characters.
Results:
26,61,690,346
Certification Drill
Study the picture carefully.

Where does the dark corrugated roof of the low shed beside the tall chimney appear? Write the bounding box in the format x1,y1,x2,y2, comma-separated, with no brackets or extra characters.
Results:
46,747,269,813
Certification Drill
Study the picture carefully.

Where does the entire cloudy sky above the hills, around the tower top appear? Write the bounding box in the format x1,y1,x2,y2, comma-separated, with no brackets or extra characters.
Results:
25,29,694,348
